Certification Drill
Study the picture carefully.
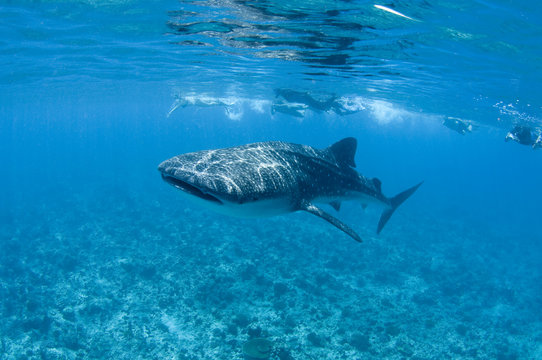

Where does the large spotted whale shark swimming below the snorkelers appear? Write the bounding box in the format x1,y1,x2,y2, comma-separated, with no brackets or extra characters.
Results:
158,137,422,242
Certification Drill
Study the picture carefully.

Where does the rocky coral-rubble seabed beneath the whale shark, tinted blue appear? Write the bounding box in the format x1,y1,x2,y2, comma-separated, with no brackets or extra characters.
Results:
0,186,542,360
